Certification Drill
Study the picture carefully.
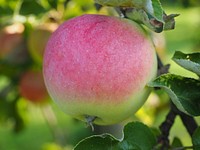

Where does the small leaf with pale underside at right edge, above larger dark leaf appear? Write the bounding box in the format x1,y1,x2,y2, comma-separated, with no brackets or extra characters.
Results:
172,51,200,76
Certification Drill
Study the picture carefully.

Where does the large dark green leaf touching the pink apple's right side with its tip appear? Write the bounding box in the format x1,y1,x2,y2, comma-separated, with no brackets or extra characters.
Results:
148,74,200,116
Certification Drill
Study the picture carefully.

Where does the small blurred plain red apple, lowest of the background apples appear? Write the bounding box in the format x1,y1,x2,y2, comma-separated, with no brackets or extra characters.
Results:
19,70,48,103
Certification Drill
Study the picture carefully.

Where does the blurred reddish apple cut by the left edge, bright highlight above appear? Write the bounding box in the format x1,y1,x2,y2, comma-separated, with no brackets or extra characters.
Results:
0,23,29,66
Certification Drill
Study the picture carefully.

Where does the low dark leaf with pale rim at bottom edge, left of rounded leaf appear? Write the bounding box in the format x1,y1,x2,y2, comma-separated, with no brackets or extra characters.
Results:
74,134,119,150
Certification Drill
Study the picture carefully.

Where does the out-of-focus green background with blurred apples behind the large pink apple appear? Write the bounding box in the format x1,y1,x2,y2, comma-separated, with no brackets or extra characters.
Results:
0,0,200,150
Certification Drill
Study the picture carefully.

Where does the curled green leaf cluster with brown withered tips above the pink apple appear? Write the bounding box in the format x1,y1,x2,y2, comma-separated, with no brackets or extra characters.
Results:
95,0,178,33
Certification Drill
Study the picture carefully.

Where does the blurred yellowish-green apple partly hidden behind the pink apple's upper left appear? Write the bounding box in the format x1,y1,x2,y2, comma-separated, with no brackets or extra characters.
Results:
28,23,58,64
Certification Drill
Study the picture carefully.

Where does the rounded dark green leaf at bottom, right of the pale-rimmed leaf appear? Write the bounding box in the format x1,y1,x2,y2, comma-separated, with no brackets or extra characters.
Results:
120,122,156,150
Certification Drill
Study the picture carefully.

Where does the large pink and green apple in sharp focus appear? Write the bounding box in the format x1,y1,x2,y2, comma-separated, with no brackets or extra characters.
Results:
43,15,157,125
